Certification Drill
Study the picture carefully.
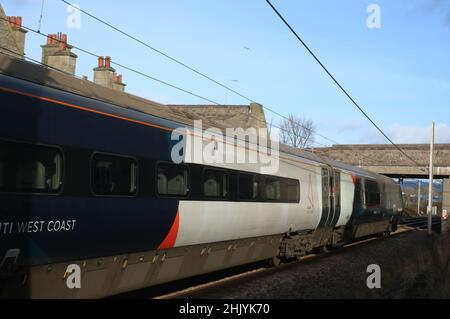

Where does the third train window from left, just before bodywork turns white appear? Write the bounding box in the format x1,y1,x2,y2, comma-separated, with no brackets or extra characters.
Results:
157,163,189,197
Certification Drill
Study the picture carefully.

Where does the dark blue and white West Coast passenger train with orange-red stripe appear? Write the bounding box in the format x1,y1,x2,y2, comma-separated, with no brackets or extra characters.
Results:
0,55,403,298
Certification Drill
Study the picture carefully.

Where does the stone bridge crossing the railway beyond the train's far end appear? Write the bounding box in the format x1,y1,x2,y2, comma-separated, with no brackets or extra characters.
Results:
312,144,450,212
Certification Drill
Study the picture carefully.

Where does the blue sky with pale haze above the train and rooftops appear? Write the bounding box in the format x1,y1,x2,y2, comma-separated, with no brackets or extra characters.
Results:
0,0,450,146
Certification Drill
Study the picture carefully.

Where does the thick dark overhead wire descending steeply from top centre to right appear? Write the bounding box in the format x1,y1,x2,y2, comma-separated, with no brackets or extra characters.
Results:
266,0,423,170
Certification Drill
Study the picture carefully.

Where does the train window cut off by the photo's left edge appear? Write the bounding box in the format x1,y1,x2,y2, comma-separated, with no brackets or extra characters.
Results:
0,141,62,194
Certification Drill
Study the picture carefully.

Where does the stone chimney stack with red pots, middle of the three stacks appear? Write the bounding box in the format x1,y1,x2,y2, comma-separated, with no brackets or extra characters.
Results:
41,32,78,75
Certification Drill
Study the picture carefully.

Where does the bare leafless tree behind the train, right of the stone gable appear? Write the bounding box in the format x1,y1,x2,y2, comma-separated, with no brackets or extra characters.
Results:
280,114,316,148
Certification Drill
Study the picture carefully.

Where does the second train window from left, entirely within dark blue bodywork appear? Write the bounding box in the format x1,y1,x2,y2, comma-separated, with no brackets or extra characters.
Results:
91,154,137,196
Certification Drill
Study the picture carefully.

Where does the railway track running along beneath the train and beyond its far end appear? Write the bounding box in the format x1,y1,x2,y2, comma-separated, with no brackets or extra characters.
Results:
113,222,441,299
